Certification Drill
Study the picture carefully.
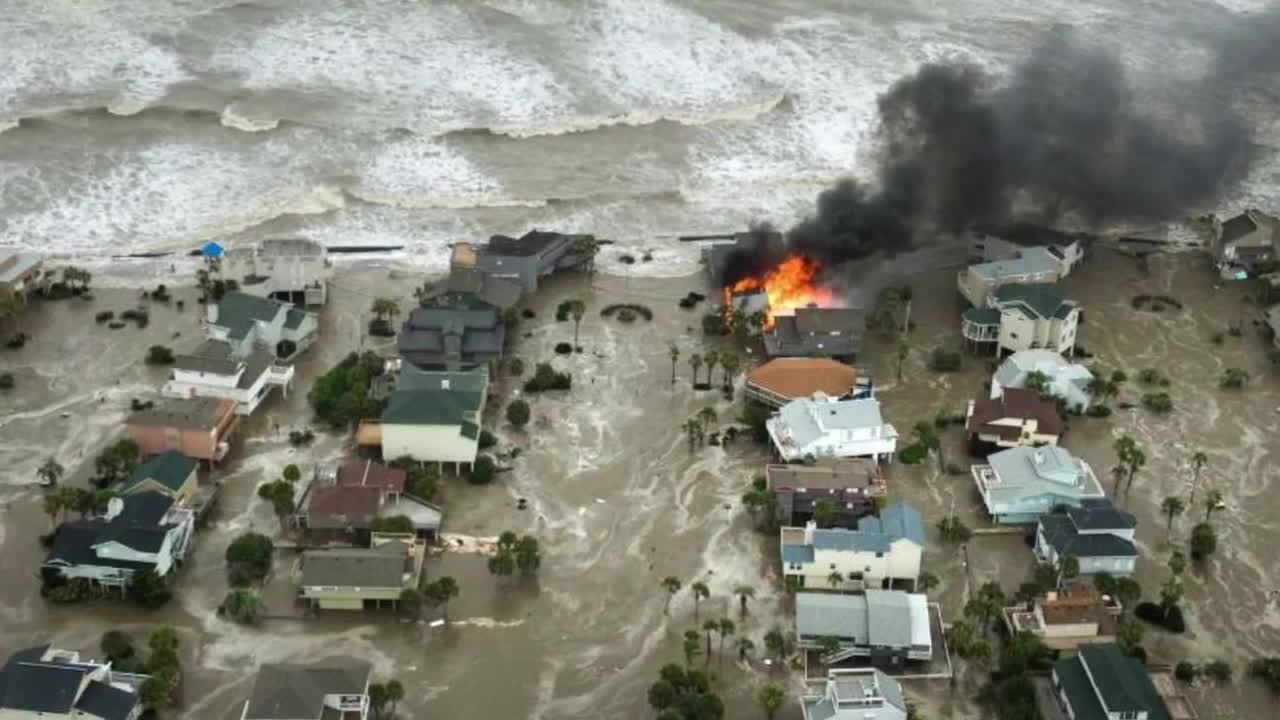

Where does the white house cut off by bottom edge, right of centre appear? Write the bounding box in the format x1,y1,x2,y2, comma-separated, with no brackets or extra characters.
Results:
800,667,908,720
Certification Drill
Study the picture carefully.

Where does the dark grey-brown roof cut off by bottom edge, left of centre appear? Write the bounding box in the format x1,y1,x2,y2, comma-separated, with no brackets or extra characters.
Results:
244,659,372,720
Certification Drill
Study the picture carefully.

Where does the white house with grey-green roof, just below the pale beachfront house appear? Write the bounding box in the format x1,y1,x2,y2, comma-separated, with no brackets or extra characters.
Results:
205,291,320,360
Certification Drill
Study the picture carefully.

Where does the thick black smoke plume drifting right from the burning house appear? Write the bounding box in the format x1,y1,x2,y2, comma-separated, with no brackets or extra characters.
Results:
721,13,1280,282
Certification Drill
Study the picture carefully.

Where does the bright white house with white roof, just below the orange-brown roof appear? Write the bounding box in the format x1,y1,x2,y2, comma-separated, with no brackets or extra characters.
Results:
765,393,897,462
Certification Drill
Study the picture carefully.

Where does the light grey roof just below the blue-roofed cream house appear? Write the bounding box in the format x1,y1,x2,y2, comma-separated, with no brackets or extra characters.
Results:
795,589,911,647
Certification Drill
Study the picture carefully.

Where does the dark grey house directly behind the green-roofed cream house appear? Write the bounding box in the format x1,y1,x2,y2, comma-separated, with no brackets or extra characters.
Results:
396,297,507,372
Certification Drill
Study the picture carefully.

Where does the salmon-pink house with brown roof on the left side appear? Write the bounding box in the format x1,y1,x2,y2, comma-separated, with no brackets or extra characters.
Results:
125,397,239,464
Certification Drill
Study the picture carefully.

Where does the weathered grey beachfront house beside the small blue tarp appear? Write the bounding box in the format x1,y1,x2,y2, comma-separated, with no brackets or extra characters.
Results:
223,237,330,302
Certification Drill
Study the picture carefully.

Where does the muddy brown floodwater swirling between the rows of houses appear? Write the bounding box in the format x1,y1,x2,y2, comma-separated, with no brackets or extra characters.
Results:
0,250,1280,720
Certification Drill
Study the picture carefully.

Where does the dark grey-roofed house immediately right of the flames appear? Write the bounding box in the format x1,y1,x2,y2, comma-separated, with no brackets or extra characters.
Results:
764,306,867,360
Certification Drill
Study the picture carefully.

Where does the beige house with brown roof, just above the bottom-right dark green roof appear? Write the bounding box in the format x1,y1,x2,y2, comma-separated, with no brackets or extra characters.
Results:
1004,583,1121,651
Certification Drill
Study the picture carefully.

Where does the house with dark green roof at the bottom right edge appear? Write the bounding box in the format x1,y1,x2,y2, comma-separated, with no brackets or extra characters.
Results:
1053,643,1170,720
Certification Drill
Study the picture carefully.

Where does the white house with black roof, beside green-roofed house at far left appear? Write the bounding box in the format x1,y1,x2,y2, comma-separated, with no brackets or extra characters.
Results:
41,492,195,589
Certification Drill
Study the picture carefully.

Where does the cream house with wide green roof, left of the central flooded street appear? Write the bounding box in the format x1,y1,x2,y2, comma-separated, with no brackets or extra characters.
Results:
381,363,489,469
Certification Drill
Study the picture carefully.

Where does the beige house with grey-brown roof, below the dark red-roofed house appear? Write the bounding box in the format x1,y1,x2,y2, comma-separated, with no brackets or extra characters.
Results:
294,533,426,610
